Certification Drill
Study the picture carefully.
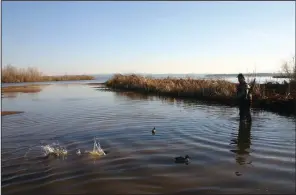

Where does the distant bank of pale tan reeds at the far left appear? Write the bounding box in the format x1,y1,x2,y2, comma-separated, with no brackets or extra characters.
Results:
1,65,95,83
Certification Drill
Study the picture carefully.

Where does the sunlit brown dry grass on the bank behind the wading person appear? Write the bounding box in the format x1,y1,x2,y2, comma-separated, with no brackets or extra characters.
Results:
106,74,260,98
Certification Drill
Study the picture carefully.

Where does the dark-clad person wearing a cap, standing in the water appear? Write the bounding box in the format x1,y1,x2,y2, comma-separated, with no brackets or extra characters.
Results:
237,73,252,122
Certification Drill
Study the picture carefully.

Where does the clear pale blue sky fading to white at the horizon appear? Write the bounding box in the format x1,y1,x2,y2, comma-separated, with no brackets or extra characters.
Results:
2,1,295,74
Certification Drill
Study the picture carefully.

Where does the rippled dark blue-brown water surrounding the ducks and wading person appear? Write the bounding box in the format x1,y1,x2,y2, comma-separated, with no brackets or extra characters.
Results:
1,85,295,194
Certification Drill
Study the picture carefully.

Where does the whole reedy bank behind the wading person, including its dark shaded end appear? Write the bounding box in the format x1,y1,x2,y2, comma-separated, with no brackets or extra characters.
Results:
106,74,296,113
